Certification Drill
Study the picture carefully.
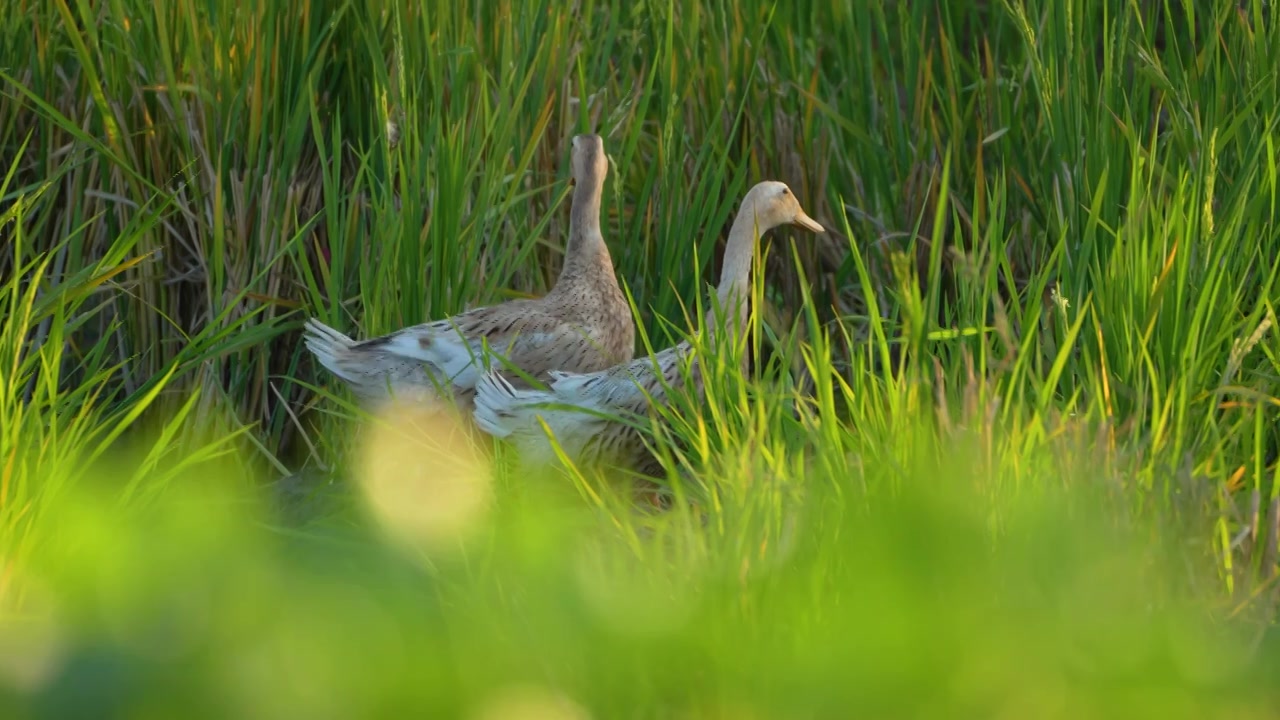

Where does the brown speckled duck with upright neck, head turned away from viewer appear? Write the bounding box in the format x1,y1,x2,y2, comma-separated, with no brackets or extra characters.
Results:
303,135,635,411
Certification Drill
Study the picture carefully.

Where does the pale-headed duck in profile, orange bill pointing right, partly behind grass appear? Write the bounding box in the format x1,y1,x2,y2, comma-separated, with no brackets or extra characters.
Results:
474,181,826,474
